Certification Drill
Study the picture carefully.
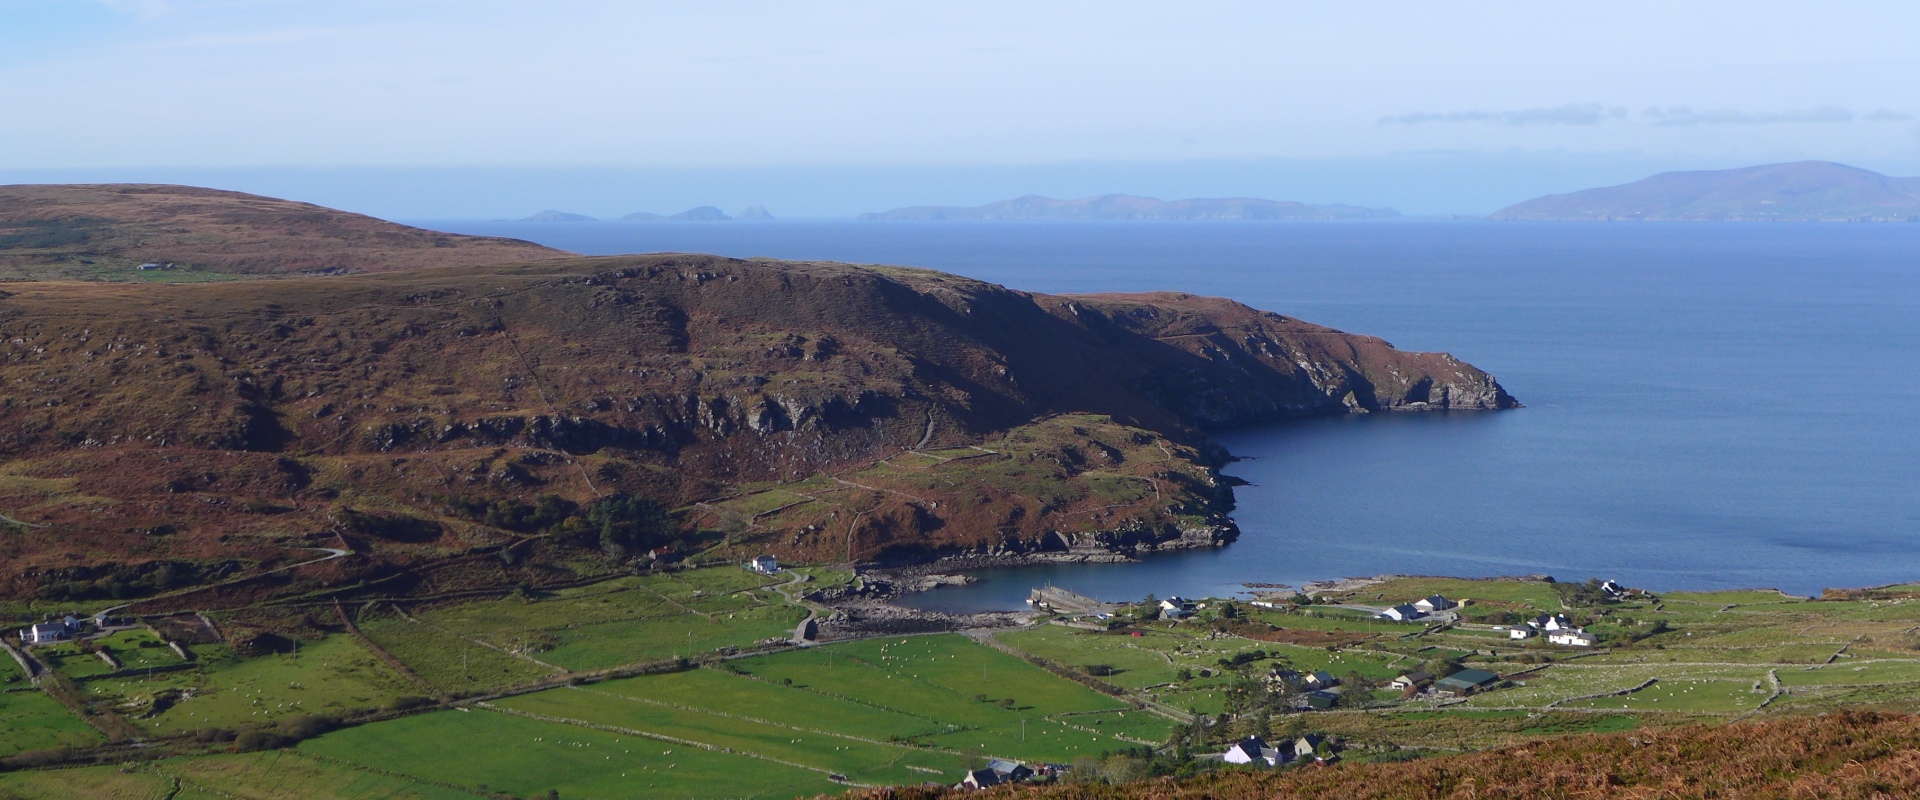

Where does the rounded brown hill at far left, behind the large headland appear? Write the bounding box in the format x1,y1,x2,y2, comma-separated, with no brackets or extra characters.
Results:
0,184,566,280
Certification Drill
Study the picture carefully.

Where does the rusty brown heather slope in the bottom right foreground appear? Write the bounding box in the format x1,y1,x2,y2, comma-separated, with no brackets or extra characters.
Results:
864,712,1920,800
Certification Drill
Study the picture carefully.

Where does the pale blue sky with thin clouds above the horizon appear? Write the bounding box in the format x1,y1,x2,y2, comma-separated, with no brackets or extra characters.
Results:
0,0,1920,217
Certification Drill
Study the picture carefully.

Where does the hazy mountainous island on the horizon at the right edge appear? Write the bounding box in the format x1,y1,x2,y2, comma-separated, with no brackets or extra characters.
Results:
1490,161,1920,223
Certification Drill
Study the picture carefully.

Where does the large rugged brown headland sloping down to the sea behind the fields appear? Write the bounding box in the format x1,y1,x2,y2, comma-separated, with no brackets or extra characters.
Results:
0,238,1515,606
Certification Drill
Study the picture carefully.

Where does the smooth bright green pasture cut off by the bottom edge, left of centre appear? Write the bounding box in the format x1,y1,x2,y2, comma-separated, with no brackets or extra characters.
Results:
300,710,845,800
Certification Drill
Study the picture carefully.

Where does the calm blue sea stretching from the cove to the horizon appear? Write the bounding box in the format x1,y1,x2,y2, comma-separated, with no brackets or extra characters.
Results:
426,221,1920,610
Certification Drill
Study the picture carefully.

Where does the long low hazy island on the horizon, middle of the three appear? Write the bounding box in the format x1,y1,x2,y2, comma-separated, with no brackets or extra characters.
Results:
860,194,1400,223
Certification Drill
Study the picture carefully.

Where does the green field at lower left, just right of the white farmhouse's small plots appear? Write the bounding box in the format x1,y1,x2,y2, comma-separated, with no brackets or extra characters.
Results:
81,635,420,733
